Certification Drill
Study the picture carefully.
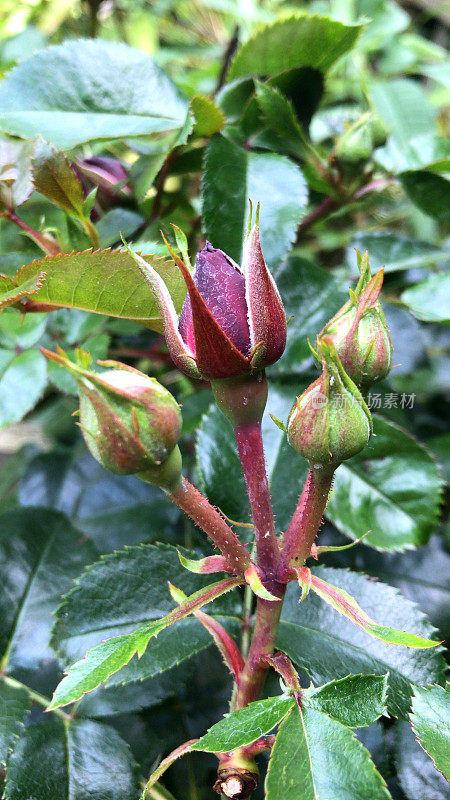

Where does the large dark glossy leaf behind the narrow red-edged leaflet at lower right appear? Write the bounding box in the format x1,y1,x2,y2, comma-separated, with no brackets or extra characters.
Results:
277,567,445,716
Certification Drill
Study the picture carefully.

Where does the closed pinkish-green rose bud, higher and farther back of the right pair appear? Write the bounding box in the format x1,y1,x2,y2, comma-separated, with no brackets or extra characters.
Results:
319,250,392,391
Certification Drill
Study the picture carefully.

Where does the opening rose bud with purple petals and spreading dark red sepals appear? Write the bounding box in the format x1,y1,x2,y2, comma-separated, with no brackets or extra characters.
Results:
124,206,286,380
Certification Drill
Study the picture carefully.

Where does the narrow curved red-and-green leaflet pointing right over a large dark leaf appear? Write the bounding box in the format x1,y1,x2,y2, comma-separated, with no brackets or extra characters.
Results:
311,575,439,649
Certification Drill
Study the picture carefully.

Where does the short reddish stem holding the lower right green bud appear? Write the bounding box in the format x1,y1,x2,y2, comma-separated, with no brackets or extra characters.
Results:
280,469,334,579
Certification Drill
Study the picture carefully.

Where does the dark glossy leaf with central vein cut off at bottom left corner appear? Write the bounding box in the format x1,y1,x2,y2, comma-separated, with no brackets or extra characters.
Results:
3,719,139,800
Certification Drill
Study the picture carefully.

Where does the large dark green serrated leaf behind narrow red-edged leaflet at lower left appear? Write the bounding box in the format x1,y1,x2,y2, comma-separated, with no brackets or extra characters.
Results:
52,545,241,700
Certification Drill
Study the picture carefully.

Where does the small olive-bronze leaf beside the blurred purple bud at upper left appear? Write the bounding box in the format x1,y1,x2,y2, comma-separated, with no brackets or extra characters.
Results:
33,142,84,217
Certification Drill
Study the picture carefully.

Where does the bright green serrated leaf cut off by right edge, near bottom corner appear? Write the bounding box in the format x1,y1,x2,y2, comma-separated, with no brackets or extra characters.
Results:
410,684,450,780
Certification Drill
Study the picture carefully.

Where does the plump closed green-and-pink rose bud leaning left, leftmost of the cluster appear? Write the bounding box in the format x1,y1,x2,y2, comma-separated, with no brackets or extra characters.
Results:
42,348,182,486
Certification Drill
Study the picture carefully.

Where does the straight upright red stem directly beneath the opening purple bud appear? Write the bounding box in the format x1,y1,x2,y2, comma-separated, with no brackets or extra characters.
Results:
234,420,280,588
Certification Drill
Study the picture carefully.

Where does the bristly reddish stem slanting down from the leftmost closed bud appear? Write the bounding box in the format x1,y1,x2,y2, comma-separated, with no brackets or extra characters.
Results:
167,477,250,573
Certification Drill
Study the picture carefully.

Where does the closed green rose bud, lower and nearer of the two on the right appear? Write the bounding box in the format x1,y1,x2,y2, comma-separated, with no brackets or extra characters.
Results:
287,337,372,469
